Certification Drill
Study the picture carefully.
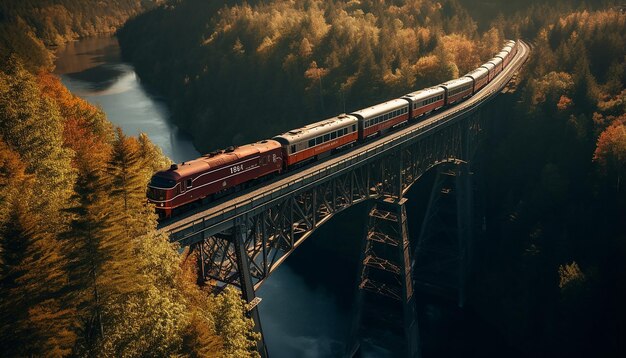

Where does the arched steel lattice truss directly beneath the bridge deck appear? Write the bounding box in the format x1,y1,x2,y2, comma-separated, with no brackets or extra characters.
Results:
193,116,480,289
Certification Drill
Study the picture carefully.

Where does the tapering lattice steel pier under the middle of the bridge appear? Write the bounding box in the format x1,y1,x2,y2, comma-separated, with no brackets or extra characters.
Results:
347,197,421,357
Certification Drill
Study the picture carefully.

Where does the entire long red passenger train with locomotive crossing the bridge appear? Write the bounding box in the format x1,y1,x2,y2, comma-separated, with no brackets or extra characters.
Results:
147,40,519,219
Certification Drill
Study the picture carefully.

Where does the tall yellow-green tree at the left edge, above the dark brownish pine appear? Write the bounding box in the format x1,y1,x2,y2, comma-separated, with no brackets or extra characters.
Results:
0,58,76,231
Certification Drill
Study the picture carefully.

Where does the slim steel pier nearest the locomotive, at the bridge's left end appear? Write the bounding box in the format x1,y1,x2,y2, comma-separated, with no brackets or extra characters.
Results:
233,218,268,358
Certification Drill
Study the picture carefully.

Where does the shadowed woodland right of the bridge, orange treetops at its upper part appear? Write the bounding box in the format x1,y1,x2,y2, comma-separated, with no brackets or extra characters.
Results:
476,6,626,357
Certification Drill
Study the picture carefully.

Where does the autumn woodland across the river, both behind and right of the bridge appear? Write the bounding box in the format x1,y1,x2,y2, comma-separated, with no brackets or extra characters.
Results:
119,0,626,356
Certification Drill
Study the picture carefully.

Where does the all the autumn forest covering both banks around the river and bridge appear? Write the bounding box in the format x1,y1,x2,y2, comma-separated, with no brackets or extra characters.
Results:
0,0,626,357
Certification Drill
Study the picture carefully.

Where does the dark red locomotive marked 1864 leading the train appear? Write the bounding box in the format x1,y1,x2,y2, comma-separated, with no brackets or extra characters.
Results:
148,140,283,218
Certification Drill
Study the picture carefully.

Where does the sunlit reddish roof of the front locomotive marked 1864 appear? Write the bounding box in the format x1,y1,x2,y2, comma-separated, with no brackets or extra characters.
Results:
154,139,281,181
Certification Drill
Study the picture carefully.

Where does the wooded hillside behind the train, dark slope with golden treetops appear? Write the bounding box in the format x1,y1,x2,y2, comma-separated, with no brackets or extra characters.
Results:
118,0,503,151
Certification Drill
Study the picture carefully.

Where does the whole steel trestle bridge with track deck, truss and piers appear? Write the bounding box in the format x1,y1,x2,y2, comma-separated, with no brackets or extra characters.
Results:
159,41,530,357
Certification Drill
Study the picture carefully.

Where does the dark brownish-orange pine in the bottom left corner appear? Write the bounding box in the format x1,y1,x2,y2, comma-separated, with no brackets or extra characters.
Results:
0,183,75,356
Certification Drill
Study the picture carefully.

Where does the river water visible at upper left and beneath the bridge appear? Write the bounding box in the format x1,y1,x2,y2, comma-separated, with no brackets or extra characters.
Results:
55,37,516,358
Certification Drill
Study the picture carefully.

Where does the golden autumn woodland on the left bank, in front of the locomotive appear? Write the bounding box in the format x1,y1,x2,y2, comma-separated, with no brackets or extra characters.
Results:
0,1,258,357
